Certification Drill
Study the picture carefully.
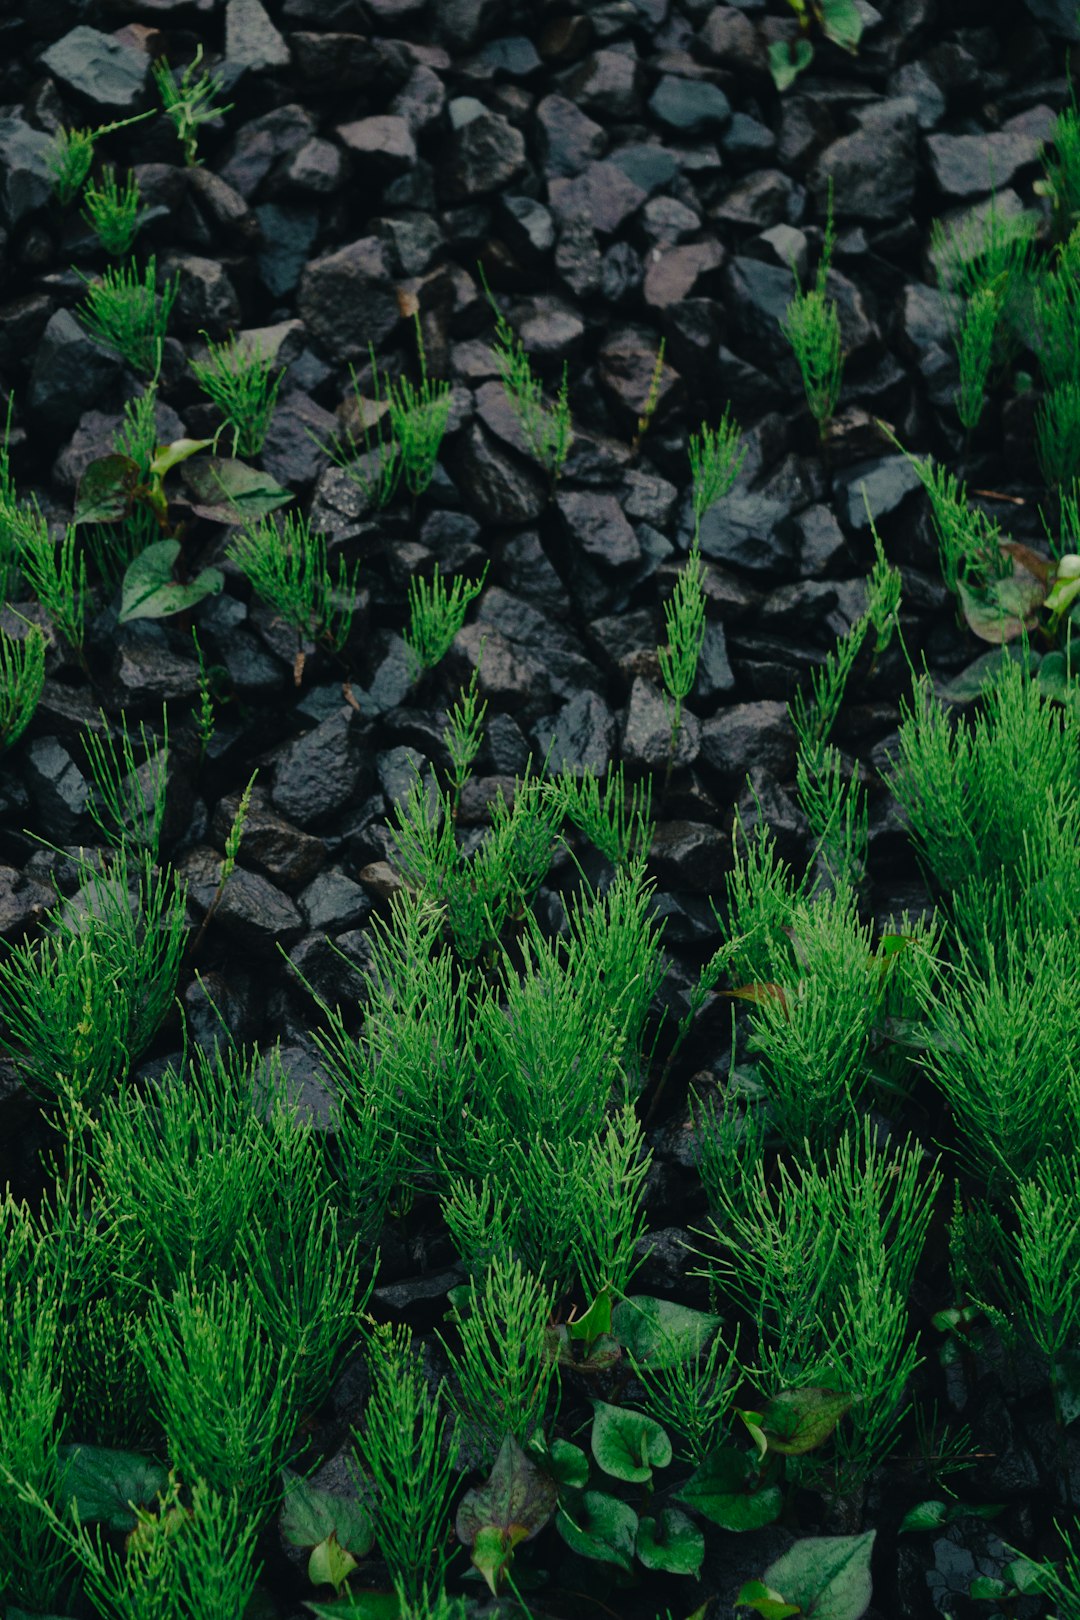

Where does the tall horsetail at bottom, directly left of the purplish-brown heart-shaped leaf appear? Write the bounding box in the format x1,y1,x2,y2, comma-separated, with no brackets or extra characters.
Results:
353,1327,458,1602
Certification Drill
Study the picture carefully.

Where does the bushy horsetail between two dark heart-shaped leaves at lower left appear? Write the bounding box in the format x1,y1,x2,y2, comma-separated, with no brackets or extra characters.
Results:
139,1277,296,1518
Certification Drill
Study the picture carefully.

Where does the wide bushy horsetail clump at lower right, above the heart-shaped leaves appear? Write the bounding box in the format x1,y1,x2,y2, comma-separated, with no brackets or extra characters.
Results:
709,1119,941,1490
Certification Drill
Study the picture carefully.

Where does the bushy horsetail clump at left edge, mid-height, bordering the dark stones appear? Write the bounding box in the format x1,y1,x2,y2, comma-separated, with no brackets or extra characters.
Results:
0,855,186,1103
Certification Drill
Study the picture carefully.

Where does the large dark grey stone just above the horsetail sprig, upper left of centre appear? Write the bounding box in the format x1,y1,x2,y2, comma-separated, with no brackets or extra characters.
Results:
296,237,402,360
